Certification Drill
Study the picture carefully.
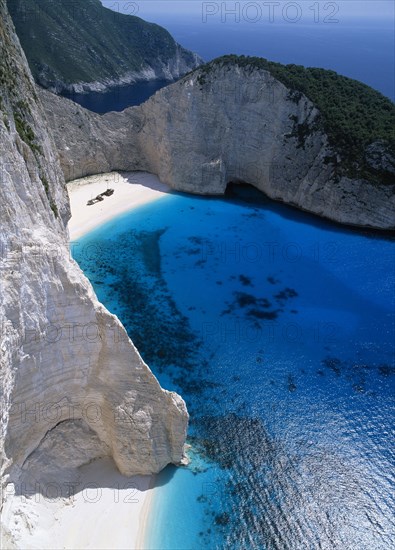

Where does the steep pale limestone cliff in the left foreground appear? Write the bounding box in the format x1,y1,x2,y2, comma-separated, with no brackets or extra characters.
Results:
0,0,188,524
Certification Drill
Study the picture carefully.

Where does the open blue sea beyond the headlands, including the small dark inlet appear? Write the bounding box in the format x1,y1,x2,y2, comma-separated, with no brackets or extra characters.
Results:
65,15,395,113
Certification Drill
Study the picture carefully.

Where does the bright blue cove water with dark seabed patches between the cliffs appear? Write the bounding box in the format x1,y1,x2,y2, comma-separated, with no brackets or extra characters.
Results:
73,190,395,550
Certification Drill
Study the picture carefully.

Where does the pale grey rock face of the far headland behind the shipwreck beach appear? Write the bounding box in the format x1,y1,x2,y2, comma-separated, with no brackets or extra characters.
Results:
40,65,395,229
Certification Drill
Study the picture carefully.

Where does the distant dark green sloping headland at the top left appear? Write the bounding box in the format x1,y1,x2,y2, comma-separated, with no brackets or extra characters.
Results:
7,0,201,87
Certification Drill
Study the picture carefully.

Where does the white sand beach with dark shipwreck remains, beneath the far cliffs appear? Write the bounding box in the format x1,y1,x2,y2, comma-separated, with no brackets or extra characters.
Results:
67,172,170,240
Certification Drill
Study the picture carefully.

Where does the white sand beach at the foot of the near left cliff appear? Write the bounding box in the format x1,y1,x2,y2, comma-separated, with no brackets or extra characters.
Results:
4,458,154,550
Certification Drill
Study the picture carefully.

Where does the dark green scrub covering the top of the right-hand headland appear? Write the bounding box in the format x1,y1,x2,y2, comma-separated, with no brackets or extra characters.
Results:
198,55,395,183
